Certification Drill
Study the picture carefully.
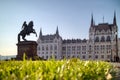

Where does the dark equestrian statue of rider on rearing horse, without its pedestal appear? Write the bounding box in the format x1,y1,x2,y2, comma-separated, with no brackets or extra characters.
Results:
18,21,37,42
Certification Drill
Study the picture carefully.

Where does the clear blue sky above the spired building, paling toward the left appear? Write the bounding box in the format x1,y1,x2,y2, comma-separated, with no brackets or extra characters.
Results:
0,0,120,55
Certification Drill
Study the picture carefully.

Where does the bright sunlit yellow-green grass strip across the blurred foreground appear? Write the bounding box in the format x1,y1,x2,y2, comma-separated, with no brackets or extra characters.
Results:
0,59,113,80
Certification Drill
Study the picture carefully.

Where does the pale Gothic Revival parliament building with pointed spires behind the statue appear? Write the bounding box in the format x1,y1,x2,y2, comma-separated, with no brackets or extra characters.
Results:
37,12,120,61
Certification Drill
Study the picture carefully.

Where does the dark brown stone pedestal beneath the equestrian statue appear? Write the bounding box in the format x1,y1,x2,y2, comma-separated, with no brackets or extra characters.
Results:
17,41,37,60
